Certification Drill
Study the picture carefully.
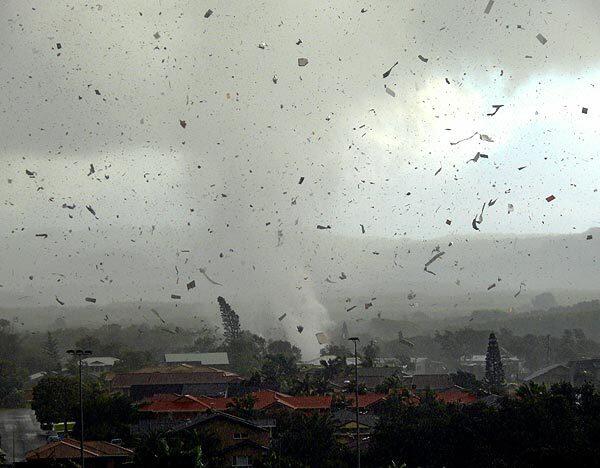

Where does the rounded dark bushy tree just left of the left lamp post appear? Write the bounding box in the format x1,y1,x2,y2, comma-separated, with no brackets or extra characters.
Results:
31,375,79,430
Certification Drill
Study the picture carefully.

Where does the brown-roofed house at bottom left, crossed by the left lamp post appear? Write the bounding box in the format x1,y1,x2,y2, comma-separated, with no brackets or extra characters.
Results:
25,439,133,468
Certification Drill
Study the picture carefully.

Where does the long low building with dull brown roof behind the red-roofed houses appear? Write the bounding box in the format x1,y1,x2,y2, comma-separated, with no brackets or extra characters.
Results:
109,364,246,401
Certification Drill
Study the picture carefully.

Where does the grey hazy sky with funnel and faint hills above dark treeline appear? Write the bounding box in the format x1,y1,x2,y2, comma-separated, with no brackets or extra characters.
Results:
0,0,600,356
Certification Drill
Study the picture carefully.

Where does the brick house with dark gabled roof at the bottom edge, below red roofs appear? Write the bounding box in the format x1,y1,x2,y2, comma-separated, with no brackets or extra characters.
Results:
170,411,271,467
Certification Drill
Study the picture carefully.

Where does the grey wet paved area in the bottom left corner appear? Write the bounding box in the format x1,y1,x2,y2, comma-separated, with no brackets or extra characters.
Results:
0,408,46,462
